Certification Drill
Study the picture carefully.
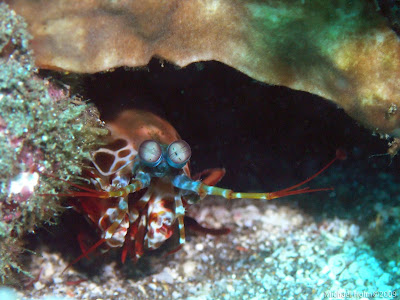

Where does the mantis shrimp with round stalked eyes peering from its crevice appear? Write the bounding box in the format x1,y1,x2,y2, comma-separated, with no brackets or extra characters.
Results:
58,110,343,266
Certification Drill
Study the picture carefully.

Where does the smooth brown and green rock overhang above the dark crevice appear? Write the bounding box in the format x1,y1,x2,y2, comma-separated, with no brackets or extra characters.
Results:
7,0,400,135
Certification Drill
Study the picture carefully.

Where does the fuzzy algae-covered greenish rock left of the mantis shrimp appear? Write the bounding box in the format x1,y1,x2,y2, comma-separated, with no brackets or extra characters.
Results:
0,3,107,283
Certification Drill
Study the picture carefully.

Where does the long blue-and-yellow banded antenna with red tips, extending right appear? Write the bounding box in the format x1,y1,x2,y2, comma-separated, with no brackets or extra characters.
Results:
172,150,346,200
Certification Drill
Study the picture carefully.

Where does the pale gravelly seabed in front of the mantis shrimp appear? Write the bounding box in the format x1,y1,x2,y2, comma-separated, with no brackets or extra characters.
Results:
10,192,400,300
